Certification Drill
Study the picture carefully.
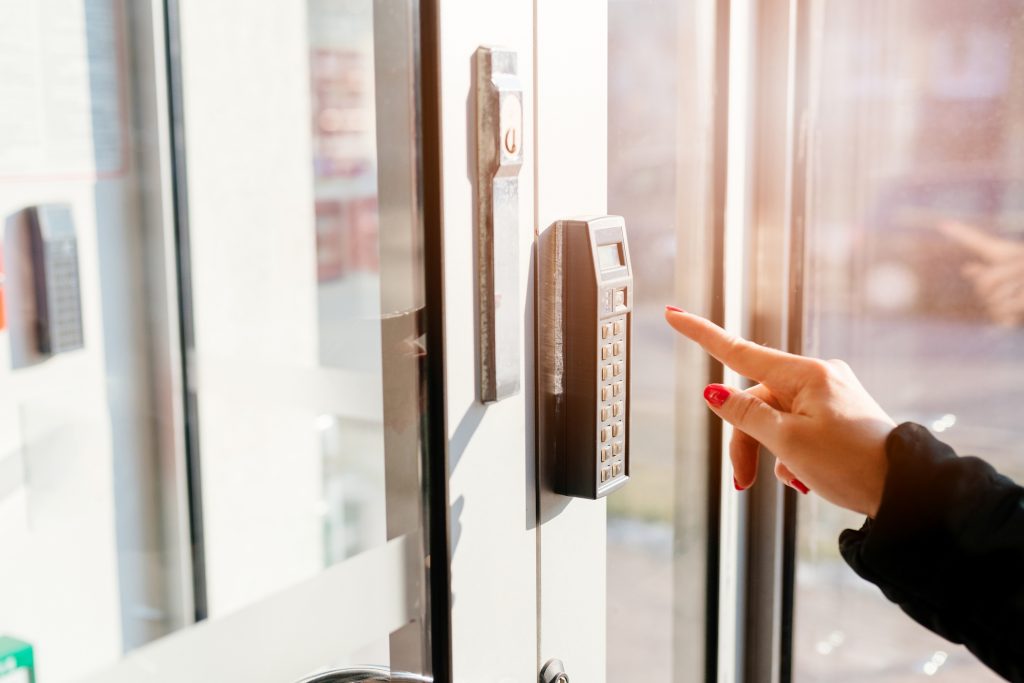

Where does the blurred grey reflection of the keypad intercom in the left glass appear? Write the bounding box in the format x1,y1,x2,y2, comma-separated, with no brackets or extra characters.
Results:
24,204,84,355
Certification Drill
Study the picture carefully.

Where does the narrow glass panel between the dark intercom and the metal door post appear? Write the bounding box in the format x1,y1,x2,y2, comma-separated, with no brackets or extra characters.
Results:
607,0,715,681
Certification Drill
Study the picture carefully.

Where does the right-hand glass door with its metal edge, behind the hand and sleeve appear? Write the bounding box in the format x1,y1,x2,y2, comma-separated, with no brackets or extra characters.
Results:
730,0,1024,682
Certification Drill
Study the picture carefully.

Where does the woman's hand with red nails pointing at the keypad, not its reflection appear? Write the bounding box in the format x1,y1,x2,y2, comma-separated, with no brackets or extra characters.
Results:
665,307,896,517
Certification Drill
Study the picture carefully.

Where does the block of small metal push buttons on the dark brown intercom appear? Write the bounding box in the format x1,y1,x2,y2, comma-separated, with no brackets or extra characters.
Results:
597,315,628,483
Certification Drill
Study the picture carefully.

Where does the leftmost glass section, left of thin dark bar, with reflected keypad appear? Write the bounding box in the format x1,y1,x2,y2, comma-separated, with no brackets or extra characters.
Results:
0,0,191,683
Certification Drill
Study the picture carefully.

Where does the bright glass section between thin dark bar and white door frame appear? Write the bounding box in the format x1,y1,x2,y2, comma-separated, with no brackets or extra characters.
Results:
181,0,426,670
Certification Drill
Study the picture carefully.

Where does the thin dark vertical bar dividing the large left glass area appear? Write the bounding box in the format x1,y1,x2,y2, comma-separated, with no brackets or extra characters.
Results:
158,0,209,622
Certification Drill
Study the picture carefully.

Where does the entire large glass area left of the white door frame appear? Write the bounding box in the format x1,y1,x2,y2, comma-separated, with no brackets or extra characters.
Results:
0,0,429,683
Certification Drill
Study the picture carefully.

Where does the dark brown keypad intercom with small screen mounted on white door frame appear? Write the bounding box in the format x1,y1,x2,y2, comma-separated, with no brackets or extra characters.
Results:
538,216,634,499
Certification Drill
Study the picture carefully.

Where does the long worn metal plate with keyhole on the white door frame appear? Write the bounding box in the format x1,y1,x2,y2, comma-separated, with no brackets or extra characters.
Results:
476,47,523,403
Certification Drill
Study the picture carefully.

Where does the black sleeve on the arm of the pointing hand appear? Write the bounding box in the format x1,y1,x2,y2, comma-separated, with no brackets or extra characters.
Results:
839,423,1024,682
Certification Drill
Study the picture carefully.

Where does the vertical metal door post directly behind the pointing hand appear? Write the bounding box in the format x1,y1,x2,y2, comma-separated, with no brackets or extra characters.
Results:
742,0,808,683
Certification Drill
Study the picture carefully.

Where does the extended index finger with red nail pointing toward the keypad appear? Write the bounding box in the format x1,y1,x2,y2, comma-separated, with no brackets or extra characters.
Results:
665,309,805,393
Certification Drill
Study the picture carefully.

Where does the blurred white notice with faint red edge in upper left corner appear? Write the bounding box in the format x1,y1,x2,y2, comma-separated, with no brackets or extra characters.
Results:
0,0,127,179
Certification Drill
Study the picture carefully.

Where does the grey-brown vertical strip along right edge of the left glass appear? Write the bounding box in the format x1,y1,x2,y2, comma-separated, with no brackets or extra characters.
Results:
373,0,430,673
